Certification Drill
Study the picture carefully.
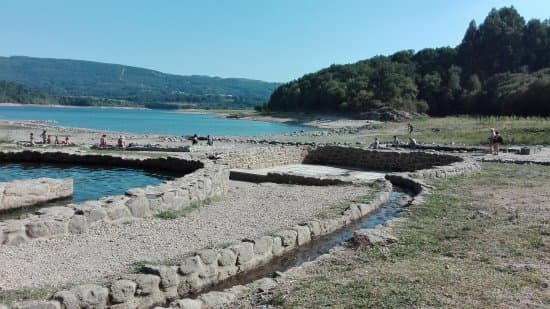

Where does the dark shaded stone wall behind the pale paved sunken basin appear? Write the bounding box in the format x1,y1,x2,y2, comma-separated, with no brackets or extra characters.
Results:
303,146,462,172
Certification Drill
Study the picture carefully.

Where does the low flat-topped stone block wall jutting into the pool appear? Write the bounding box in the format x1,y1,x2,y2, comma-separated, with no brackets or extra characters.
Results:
0,178,73,211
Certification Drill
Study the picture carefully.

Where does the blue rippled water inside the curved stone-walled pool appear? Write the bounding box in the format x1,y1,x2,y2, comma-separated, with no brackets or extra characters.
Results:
0,163,174,203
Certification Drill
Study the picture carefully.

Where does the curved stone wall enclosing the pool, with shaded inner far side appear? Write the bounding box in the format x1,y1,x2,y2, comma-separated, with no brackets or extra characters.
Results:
0,152,229,245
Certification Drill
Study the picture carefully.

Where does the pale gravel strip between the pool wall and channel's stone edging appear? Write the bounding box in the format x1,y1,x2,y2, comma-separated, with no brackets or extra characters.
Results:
0,181,374,290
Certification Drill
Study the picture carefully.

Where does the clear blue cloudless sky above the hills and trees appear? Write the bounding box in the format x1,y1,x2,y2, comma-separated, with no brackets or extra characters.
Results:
0,0,550,82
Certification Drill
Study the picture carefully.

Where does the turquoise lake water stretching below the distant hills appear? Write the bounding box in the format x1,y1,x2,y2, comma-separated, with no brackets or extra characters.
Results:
0,106,308,136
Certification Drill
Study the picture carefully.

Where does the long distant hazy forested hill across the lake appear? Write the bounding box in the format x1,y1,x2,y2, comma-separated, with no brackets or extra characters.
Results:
0,56,278,107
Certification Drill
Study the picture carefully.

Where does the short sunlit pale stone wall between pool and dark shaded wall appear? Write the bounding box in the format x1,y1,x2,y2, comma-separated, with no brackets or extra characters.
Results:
223,146,311,169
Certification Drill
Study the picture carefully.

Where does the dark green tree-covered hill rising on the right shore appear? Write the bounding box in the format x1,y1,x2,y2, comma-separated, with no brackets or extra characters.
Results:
268,7,550,116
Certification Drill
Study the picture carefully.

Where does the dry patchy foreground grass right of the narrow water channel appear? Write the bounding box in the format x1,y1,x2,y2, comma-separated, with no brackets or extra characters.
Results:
264,164,550,308
